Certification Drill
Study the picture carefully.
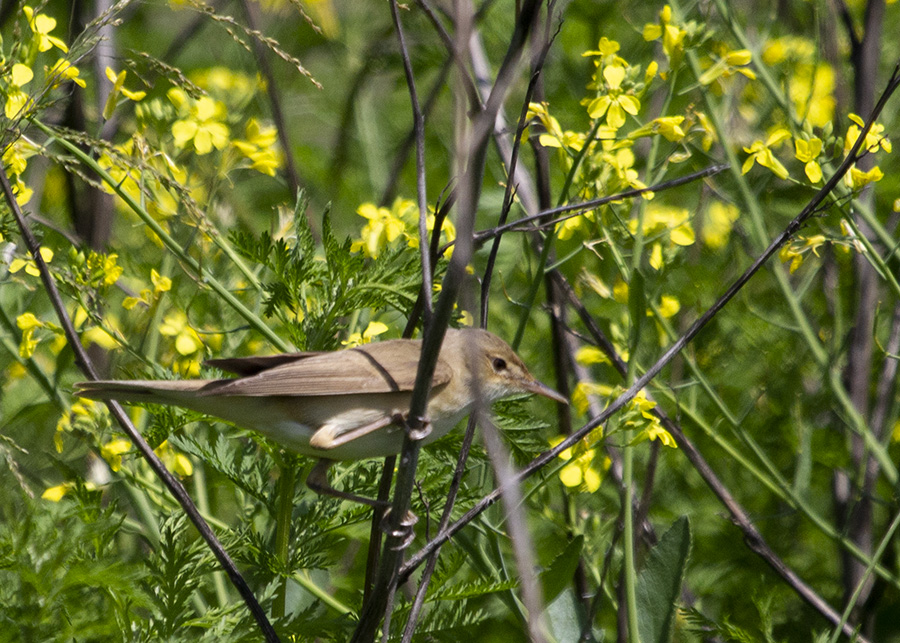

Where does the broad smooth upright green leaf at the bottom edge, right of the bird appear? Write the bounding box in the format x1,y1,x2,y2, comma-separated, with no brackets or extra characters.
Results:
637,516,691,643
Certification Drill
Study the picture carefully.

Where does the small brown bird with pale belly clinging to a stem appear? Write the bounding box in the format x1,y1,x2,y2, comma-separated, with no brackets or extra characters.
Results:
75,328,567,505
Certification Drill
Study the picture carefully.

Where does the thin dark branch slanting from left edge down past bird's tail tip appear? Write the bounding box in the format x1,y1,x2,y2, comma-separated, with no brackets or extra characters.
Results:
0,161,279,643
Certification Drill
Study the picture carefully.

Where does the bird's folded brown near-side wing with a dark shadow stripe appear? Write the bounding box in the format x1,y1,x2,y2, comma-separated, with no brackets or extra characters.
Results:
198,340,452,397
